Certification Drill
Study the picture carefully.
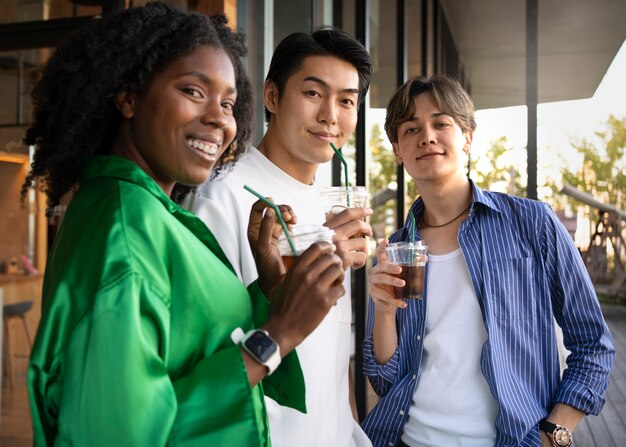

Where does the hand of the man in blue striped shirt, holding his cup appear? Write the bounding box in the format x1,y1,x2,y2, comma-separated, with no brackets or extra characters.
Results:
369,239,407,315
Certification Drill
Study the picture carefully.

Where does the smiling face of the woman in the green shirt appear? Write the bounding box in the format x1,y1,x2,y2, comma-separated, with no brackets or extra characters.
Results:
112,46,237,195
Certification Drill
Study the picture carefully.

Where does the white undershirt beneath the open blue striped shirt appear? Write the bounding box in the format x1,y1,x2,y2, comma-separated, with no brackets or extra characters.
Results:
402,248,498,447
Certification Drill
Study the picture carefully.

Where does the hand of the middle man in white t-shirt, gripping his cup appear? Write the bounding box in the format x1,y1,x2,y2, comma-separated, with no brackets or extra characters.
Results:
324,207,372,270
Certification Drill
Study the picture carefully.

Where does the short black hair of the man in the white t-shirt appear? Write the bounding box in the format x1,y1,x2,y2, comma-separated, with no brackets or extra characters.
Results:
265,26,372,122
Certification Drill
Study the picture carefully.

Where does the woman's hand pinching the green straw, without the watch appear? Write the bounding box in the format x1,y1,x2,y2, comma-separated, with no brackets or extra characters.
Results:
248,200,297,297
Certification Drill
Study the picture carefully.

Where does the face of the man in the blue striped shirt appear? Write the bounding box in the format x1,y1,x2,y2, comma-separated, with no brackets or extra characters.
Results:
393,92,473,188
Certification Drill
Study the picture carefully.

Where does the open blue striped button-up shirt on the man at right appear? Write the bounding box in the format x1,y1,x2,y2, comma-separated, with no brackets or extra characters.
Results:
363,183,615,446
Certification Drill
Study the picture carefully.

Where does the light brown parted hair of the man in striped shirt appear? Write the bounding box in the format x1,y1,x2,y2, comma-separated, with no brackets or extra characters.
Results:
385,75,476,143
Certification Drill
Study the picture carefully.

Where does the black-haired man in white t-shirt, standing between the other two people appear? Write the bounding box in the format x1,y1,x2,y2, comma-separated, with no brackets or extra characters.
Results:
188,28,372,447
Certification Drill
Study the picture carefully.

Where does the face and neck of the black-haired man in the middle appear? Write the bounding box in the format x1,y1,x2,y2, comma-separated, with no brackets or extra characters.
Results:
259,56,359,183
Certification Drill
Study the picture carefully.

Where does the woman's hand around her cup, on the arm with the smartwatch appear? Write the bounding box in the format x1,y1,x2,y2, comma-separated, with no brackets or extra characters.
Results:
264,242,345,355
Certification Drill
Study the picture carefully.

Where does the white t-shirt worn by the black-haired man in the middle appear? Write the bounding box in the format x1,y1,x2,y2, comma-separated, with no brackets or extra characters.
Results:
186,147,371,447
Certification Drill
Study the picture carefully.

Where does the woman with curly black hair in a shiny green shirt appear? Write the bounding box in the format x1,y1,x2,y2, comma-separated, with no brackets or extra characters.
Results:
23,3,343,446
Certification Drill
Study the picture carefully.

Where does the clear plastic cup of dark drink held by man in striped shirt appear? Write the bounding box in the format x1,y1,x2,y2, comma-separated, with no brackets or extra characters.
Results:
385,241,428,300
